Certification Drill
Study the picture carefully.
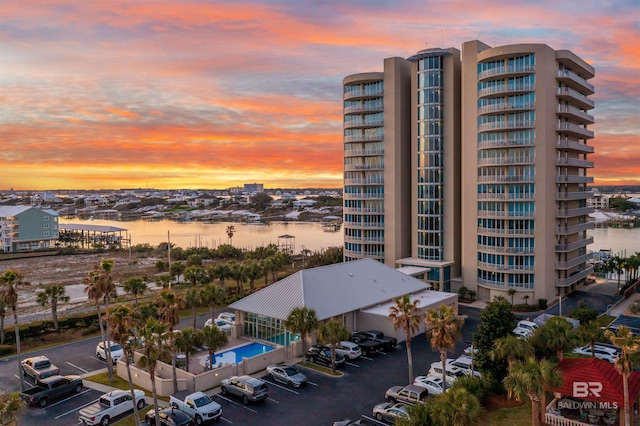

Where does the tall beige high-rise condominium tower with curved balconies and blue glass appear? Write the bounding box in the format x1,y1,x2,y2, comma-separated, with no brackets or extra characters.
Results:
343,41,594,303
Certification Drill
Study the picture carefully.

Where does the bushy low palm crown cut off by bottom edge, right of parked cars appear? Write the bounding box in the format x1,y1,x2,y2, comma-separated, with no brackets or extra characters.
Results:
430,386,482,426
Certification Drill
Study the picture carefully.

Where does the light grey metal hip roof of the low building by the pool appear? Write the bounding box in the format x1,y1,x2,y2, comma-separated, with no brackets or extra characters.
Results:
229,259,429,320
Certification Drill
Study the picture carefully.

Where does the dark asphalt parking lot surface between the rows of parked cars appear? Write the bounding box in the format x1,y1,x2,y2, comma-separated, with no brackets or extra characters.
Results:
12,307,479,426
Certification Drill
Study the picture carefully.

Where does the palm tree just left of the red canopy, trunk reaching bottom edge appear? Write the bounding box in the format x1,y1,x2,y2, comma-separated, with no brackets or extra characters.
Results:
503,358,562,426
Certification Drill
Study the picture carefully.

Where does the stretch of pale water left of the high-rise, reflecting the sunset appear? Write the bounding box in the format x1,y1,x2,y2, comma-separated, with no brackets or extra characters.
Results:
60,219,344,253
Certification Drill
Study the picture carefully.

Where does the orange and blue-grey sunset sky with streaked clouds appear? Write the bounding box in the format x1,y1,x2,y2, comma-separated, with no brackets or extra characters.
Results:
0,0,640,190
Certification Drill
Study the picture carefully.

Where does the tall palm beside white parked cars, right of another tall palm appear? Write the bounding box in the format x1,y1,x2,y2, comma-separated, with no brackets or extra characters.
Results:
424,305,464,389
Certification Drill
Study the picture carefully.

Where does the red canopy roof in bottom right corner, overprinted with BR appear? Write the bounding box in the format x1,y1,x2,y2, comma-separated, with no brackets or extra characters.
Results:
547,358,640,407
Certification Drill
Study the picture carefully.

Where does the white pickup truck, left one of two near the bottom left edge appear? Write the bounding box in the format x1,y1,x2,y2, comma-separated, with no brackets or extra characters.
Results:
79,389,145,426
